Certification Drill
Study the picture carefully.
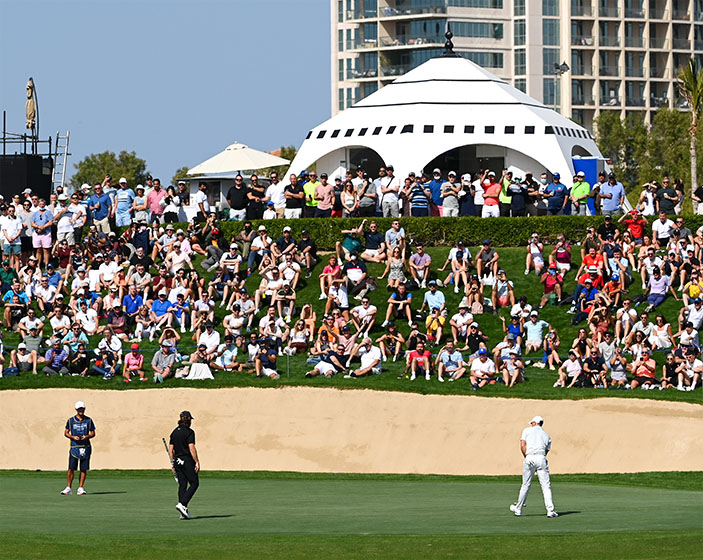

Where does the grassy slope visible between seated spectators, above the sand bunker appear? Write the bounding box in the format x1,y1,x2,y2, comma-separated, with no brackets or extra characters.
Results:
0,246,703,403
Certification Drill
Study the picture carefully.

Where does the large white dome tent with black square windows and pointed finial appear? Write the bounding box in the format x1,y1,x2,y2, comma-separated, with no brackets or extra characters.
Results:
290,33,603,186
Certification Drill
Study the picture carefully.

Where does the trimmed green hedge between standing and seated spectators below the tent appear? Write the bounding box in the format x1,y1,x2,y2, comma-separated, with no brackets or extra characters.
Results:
172,215,703,251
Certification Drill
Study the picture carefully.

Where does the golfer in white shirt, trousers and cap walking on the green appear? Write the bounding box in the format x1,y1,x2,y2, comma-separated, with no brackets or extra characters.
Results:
510,416,559,517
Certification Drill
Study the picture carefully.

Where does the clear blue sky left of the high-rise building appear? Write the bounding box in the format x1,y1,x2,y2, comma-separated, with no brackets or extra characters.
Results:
0,0,330,181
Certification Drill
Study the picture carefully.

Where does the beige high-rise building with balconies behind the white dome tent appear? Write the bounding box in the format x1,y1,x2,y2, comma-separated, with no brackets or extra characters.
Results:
331,0,703,128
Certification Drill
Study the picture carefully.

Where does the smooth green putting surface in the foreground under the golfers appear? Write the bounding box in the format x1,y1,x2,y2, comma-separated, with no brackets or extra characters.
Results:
0,472,703,558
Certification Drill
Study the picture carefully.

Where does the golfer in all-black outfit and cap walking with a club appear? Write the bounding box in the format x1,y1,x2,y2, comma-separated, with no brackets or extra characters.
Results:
168,410,200,519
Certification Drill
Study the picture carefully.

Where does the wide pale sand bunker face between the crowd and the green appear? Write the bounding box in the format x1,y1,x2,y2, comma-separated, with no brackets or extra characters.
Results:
0,387,703,475
